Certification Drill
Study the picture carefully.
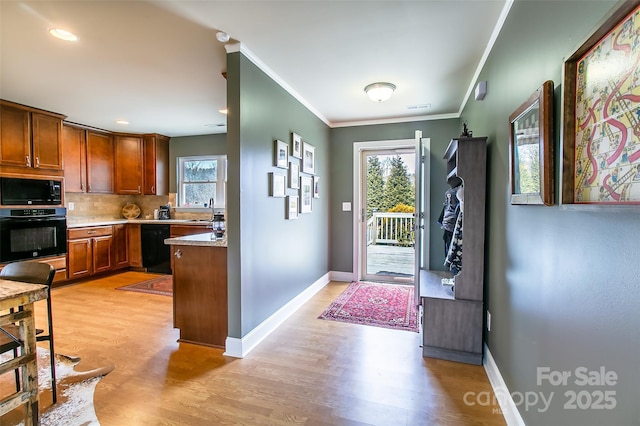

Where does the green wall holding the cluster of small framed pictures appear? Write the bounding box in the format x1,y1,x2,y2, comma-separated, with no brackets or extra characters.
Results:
227,49,330,338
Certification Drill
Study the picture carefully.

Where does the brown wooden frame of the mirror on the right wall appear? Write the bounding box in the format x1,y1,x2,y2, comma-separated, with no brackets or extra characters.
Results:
509,80,554,206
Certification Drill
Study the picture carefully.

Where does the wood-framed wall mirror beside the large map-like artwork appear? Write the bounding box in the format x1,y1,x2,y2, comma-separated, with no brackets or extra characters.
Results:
509,80,554,206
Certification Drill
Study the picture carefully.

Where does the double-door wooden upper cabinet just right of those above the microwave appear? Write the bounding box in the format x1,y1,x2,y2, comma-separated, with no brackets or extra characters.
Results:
62,125,115,194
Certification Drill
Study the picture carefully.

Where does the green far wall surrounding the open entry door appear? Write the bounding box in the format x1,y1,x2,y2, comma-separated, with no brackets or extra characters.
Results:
329,119,462,272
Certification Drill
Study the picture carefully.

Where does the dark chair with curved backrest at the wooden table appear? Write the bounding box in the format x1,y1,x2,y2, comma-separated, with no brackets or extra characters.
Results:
0,261,58,404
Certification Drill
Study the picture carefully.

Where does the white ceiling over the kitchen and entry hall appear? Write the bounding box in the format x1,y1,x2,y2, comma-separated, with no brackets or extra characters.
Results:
0,0,511,136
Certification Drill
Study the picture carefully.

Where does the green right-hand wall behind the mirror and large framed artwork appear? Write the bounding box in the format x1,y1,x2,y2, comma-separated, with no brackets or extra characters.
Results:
462,0,640,426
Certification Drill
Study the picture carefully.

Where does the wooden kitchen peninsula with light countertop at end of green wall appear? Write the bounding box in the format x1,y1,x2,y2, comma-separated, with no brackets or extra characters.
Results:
164,232,227,348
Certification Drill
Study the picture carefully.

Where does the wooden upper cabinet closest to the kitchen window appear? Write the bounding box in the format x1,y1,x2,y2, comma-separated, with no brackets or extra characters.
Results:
143,134,169,195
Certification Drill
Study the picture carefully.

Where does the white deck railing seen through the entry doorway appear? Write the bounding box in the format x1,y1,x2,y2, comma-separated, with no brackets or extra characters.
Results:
367,213,415,246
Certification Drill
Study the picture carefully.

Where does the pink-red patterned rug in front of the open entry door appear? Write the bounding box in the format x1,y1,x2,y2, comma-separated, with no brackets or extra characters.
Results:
318,282,418,333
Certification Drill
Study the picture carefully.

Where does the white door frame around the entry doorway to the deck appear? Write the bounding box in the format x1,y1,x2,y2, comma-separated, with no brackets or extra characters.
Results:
352,138,420,281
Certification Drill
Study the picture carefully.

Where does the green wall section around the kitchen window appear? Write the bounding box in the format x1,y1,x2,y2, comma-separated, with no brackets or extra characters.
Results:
169,133,227,192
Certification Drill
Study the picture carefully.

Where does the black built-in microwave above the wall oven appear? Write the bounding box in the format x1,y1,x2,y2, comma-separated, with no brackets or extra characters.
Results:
0,177,62,206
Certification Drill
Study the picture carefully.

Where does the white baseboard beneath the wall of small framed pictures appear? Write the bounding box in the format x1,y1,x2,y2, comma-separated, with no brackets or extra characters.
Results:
223,272,329,358
